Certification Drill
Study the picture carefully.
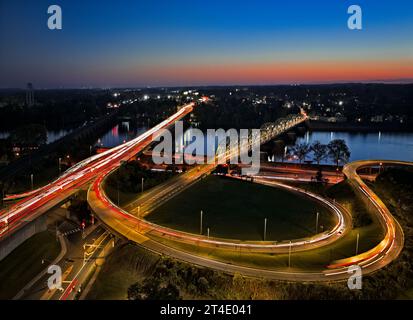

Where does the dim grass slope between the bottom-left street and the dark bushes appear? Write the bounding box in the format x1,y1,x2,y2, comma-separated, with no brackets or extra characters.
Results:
87,244,159,300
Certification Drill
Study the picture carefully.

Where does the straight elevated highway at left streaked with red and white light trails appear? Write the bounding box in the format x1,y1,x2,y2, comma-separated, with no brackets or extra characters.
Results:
0,103,195,241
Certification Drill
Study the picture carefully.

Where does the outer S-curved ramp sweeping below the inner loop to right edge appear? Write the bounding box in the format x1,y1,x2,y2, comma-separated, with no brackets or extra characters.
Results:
88,161,413,281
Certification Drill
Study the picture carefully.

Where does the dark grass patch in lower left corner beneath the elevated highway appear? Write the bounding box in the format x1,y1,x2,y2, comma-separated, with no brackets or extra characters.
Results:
0,231,60,300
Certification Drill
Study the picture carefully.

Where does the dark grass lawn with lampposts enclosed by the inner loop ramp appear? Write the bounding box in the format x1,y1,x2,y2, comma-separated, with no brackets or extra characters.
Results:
146,176,335,241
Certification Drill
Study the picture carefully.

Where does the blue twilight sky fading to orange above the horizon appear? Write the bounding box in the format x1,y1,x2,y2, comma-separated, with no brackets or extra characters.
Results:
0,0,413,88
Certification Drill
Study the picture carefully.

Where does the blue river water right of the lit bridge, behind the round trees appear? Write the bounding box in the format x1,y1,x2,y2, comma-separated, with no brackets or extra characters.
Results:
296,131,413,161
